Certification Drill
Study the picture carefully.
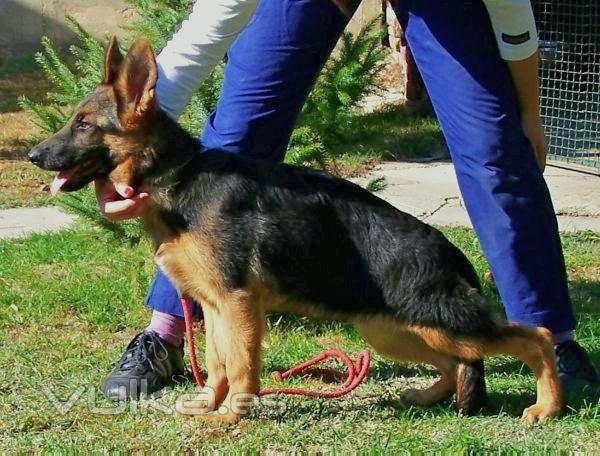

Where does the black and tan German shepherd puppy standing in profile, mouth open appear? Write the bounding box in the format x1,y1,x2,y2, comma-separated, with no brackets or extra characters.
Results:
29,37,561,422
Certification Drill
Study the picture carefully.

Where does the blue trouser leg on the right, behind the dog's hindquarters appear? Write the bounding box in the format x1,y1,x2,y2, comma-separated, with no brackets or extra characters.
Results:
394,0,575,333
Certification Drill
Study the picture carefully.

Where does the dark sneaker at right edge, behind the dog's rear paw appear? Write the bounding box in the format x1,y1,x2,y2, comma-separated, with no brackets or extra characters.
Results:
556,340,600,402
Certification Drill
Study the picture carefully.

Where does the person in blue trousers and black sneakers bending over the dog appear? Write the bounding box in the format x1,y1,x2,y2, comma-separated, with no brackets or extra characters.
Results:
97,0,600,398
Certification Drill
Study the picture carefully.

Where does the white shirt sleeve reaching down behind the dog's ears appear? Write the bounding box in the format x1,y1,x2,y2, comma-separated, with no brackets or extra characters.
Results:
156,0,258,119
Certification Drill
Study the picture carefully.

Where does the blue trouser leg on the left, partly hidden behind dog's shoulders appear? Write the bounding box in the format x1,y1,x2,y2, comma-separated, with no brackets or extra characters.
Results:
146,0,347,316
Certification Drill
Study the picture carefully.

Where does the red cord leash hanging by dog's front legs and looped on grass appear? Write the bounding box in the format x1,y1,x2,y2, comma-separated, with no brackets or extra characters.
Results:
181,298,371,399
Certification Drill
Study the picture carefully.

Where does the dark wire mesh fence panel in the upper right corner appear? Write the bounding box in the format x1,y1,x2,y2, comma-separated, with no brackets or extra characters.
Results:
533,0,600,173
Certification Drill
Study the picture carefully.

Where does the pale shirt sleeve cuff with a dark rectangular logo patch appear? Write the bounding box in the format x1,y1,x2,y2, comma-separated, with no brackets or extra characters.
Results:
483,0,538,60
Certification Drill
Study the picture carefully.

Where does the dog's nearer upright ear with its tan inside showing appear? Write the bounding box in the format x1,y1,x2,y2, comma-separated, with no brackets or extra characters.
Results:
115,39,158,127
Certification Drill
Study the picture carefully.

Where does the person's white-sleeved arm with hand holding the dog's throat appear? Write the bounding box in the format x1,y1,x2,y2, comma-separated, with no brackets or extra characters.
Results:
96,0,258,221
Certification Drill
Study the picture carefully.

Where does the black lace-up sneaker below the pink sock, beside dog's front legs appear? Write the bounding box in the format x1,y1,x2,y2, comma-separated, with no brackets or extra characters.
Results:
100,330,184,401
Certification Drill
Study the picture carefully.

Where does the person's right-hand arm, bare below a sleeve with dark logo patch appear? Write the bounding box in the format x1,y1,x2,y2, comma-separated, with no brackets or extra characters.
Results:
483,0,548,171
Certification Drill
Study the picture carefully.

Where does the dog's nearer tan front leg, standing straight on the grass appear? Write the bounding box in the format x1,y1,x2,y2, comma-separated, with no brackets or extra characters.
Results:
206,292,265,423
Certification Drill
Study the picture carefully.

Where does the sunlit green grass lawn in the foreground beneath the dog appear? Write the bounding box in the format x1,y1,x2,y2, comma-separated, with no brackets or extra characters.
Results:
0,228,600,454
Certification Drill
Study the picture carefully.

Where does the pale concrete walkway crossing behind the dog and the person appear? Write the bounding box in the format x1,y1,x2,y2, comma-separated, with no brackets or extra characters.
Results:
0,162,600,239
